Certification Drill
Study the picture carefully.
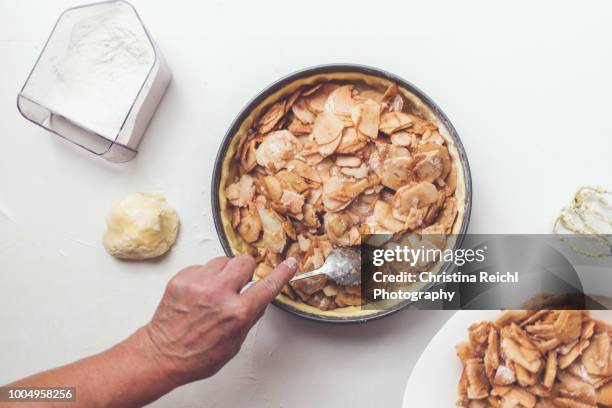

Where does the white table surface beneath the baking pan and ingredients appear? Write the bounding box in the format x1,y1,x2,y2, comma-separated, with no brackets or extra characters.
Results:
0,0,612,408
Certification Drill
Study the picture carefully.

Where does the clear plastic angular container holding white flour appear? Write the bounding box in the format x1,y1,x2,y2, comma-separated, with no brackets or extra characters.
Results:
17,0,172,162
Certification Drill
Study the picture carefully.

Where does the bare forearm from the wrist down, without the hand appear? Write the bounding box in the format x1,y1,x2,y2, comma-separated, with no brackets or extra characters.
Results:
0,328,175,408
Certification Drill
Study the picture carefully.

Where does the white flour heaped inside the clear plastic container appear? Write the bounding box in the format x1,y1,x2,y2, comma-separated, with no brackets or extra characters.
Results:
40,4,155,140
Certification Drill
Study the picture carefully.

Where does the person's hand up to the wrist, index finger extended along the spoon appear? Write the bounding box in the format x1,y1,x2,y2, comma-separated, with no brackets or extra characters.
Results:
143,255,297,387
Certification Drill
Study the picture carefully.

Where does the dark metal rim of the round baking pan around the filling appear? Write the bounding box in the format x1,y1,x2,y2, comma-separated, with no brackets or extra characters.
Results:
211,64,472,324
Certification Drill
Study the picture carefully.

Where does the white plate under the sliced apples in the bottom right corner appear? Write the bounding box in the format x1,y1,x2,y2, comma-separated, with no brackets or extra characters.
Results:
402,310,612,408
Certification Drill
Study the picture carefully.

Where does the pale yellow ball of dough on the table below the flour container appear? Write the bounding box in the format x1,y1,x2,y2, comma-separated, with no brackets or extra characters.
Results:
103,193,179,259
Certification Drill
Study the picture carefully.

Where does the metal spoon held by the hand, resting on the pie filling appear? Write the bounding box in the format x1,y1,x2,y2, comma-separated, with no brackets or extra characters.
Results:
290,248,361,286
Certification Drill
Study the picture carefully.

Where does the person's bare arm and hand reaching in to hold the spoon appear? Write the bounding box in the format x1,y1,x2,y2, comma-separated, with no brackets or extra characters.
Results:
0,255,297,408
